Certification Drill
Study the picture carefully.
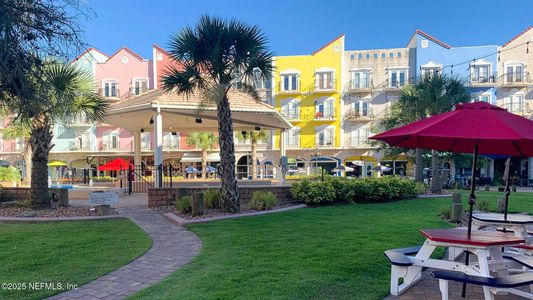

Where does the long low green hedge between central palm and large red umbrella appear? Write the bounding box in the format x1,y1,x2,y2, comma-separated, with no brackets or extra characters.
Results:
291,176,425,204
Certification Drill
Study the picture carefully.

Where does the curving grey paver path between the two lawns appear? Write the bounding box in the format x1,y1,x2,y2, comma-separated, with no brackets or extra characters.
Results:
49,206,202,299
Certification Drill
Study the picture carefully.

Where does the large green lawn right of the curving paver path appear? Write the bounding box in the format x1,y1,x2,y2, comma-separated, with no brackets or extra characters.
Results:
133,192,533,299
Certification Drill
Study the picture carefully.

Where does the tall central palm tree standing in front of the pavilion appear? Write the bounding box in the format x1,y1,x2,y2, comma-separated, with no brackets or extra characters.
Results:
163,16,272,212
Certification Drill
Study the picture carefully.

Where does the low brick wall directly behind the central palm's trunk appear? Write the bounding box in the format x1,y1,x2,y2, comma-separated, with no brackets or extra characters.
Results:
148,185,293,207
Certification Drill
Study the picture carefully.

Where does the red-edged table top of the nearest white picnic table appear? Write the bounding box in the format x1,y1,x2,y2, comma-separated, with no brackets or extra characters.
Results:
420,228,525,247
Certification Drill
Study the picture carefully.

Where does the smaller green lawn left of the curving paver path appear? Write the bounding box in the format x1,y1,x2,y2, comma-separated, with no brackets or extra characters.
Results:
0,219,152,299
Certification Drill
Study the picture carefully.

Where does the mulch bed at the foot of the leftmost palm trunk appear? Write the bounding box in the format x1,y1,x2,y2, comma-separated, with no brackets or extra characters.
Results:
0,206,118,218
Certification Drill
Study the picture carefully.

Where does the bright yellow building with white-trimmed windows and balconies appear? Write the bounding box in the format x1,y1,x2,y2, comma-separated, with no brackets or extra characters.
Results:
273,35,344,174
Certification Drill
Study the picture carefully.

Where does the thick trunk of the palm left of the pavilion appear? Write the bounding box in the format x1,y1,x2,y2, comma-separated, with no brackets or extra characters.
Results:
30,117,53,208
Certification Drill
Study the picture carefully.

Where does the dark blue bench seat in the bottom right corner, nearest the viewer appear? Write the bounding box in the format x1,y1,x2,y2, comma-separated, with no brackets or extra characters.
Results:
431,270,533,300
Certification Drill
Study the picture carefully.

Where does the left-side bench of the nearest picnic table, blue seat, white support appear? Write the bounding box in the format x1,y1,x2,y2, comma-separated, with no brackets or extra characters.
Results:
384,246,422,296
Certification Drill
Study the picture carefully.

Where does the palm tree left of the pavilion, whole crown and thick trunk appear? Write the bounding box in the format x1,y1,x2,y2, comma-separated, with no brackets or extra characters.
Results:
9,61,107,207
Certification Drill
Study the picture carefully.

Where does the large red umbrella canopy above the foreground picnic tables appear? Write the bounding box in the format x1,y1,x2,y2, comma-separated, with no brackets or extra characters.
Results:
370,102,533,157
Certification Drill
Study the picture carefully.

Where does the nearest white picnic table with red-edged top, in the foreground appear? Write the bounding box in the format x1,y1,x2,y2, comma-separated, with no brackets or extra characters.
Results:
389,228,524,299
